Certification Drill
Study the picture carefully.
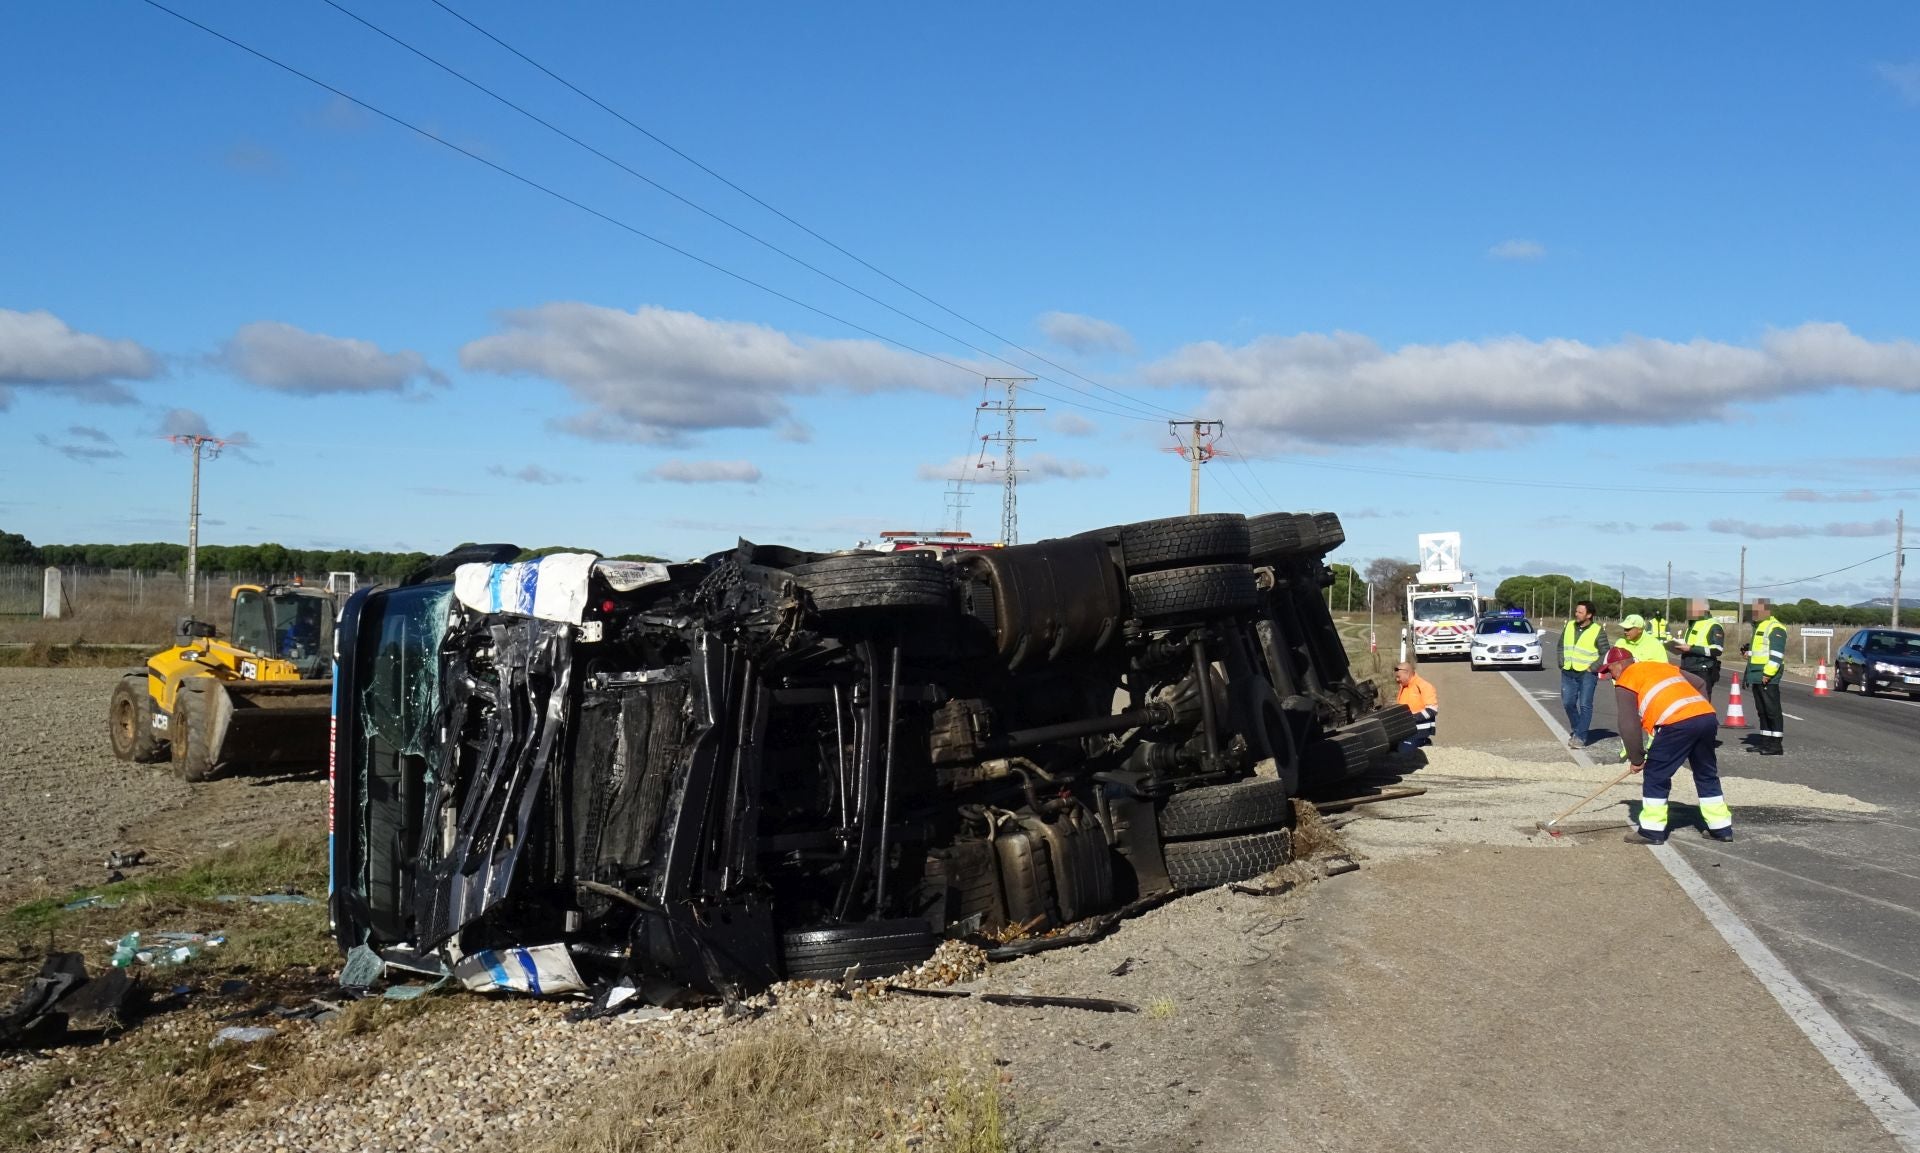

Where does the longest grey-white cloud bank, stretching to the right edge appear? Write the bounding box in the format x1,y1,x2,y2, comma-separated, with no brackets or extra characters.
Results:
1146,324,1920,449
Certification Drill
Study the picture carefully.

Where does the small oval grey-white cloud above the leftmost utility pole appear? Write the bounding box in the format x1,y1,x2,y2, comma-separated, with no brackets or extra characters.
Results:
215,320,447,397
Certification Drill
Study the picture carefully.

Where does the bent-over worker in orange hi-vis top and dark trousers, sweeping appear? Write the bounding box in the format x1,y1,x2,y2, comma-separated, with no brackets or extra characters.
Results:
1599,648,1734,844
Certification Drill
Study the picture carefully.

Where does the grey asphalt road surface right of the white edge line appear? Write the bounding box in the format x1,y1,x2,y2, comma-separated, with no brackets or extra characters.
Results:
1513,658,1920,1097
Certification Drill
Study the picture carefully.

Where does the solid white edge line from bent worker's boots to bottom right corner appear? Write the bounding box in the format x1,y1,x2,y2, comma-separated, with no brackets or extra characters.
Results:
1647,844,1920,1153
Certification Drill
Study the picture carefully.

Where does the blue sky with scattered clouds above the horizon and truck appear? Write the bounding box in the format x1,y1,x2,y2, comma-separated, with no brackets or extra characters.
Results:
0,0,1920,599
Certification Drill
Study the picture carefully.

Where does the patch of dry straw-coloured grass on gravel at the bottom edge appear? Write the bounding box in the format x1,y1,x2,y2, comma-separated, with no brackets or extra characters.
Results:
549,1026,1008,1153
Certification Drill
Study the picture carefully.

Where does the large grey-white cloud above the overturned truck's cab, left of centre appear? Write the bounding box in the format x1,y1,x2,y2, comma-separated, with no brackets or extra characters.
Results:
461,301,985,443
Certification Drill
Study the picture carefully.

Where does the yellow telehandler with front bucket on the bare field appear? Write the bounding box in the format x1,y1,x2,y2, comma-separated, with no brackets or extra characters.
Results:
108,585,336,781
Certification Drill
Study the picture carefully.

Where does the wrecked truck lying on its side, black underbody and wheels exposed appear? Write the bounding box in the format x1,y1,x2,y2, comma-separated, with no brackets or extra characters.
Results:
330,514,1413,992
